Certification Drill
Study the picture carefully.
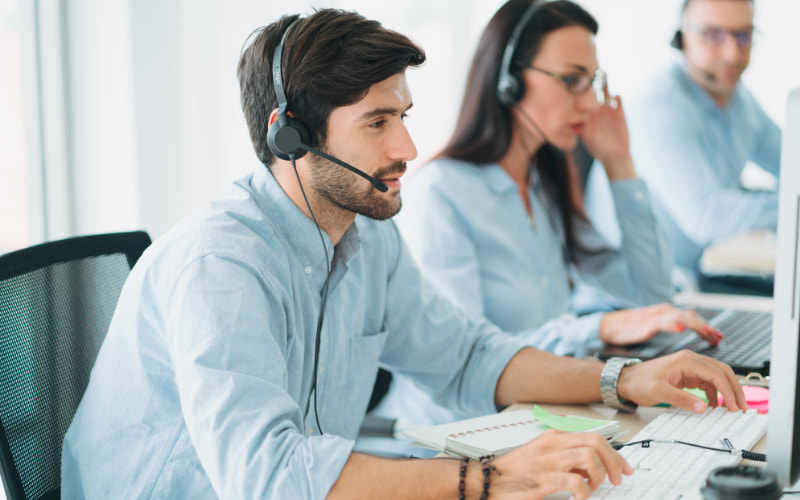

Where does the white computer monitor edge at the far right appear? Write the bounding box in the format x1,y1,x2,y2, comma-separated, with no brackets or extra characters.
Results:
767,87,800,486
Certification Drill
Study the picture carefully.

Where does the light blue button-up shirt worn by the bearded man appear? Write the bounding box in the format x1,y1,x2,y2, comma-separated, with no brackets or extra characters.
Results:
62,167,523,499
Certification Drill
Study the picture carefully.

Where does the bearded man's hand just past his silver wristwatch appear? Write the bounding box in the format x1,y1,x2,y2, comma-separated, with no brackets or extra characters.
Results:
617,351,747,412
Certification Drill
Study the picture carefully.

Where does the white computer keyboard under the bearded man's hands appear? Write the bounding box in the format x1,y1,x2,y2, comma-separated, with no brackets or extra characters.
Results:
591,408,767,500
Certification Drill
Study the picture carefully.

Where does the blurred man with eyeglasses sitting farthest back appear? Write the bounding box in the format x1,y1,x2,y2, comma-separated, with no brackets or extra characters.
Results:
587,0,781,284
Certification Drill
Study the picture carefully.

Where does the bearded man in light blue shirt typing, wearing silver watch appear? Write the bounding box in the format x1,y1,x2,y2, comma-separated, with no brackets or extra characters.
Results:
62,9,746,499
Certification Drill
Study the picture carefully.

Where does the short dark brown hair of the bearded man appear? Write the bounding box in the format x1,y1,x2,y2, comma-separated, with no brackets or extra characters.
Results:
237,9,425,167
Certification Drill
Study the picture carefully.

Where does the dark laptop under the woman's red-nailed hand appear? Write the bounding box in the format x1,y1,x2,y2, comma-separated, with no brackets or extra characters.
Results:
597,308,772,376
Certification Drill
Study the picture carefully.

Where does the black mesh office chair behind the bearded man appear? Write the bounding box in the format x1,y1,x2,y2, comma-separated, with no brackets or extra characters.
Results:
0,231,150,500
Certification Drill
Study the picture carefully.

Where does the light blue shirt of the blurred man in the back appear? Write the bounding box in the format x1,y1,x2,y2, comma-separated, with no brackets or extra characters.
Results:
587,61,781,275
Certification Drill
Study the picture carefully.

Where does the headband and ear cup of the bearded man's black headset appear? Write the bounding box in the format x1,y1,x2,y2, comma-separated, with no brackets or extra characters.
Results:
267,19,311,160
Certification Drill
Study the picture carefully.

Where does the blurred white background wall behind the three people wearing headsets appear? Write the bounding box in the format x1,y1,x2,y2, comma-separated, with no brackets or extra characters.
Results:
62,0,800,242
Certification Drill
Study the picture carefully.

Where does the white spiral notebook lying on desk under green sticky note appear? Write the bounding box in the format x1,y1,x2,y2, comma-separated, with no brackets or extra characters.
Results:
403,406,620,459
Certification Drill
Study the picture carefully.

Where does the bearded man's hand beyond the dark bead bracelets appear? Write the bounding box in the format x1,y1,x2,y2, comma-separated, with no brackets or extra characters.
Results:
491,430,633,500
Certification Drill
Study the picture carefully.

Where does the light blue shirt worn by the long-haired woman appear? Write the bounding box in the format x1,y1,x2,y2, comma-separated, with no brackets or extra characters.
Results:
378,159,672,424
